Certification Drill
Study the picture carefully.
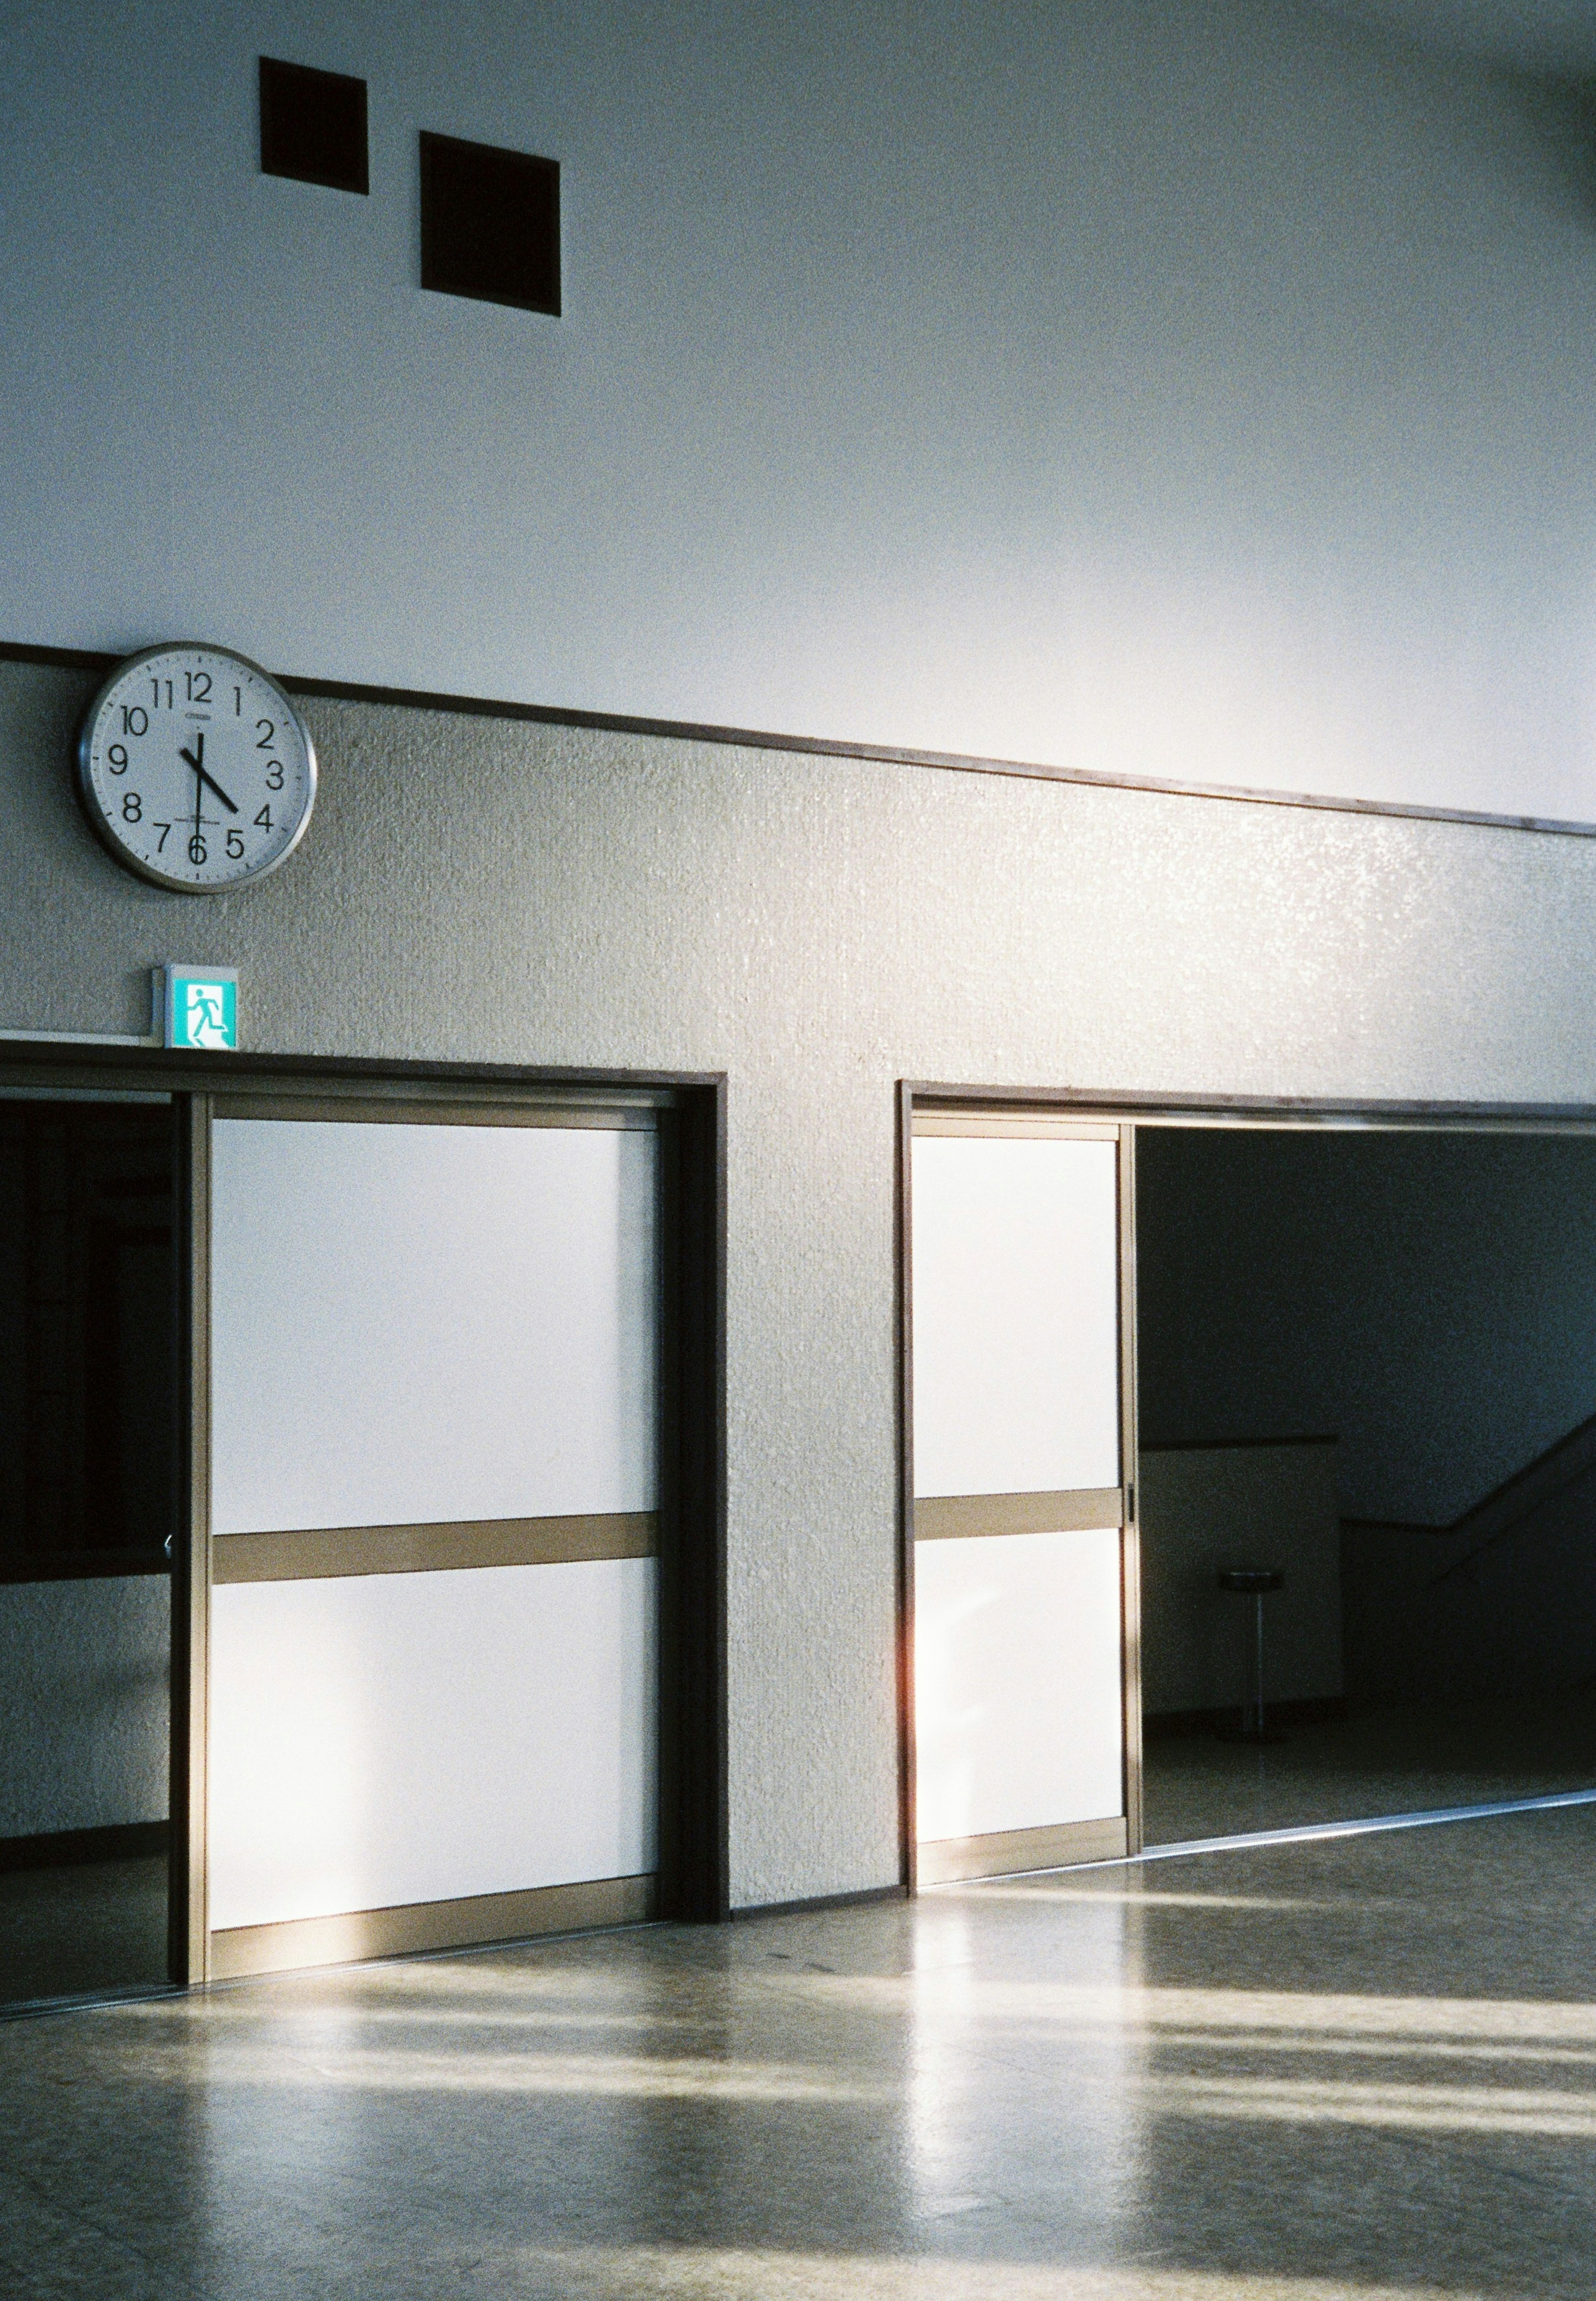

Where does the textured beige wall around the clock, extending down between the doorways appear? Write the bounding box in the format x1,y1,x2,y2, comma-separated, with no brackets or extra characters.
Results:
0,665,1596,1903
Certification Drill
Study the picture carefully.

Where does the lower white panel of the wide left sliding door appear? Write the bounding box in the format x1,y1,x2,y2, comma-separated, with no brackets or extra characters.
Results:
209,1564,658,1928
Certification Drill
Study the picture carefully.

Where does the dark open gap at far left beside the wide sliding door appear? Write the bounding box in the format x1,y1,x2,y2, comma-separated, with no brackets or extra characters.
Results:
0,1095,182,2004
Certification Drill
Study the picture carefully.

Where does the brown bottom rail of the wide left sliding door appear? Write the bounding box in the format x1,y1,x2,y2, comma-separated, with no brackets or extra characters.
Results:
212,1875,658,1981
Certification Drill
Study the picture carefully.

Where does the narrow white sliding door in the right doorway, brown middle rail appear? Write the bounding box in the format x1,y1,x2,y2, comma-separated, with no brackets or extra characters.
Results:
911,1114,1138,1885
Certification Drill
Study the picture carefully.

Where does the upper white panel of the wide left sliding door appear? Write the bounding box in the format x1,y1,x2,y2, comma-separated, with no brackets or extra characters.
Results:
212,1118,655,1535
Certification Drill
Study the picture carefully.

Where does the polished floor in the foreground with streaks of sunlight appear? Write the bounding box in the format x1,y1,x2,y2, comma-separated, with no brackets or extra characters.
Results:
0,1808,1596,2301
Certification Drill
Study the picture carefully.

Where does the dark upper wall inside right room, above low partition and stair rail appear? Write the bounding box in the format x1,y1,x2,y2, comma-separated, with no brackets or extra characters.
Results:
1136,1128,1596,1525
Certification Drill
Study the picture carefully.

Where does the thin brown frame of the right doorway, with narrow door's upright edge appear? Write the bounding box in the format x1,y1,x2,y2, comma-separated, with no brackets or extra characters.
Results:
894,1079,1596,1894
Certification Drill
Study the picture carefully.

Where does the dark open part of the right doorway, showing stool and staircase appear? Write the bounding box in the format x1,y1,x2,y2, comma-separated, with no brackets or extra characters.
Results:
1136,1128,1596,1845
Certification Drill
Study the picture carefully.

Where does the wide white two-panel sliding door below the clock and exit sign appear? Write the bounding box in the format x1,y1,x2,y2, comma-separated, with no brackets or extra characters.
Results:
207,1102,658,1976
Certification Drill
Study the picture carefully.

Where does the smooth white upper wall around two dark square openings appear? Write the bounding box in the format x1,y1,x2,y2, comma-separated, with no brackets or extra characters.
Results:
0,0,1596,821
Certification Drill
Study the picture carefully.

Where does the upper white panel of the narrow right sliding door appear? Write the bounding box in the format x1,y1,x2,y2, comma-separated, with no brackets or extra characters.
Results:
913,1134,1120,1495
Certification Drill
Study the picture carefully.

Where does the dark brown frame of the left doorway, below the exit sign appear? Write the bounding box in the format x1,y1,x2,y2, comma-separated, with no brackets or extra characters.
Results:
0,1040,732,1988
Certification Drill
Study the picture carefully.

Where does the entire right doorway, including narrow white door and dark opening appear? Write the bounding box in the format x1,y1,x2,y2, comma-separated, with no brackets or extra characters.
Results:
899,1086,1596,1885
